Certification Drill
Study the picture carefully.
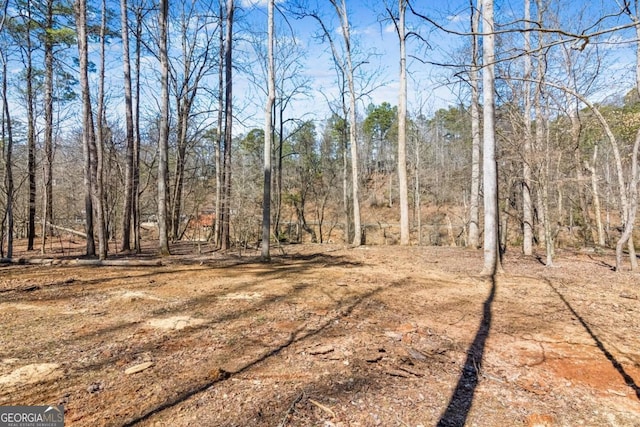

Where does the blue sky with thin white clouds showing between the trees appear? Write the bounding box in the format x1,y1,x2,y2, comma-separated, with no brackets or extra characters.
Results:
3,0,635,138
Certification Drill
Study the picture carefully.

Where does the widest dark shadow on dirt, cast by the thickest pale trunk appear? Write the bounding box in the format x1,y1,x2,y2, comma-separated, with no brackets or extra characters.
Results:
437,275,497,427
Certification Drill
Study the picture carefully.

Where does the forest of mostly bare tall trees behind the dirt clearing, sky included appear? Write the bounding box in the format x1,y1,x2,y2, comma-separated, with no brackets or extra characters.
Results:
0,0,640,269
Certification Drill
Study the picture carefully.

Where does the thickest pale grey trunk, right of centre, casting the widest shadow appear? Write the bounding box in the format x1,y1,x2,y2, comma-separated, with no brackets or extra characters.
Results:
482,0,501,275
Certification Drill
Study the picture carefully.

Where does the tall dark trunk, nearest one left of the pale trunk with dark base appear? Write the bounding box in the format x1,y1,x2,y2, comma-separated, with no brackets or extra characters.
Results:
220,0,235,250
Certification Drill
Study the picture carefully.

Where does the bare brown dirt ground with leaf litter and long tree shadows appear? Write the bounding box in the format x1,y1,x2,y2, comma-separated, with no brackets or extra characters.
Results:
0,243,640,427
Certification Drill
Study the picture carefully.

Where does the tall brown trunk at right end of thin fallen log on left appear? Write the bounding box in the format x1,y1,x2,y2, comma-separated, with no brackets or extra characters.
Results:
74,0,96,256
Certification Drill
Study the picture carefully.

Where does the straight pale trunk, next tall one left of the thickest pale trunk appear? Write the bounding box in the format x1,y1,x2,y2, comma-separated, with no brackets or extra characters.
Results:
398,0,410,245
